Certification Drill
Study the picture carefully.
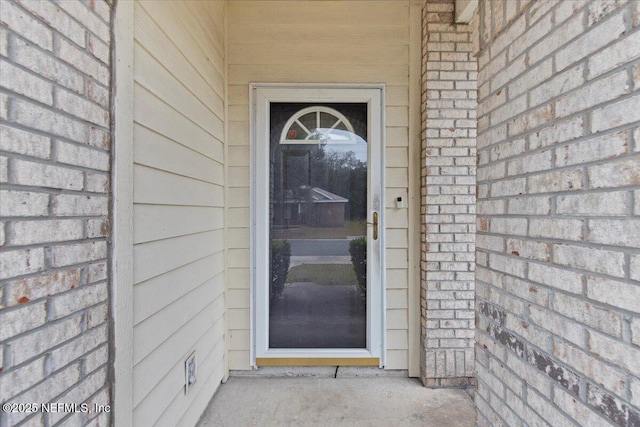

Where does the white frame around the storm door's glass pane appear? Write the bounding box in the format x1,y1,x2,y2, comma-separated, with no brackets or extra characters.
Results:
249,83,386,367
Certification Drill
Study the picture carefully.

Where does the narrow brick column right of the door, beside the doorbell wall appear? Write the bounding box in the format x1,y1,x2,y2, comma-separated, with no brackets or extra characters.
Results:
421,0,477,387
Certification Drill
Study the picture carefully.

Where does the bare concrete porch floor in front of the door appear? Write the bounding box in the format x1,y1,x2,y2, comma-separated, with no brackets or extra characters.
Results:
198,377,476,427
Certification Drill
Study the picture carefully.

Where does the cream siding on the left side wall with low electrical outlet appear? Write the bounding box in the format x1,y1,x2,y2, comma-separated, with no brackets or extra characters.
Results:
133,1,226,425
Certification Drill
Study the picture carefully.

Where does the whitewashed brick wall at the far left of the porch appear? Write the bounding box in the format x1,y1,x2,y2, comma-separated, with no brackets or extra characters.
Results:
0,0,111,426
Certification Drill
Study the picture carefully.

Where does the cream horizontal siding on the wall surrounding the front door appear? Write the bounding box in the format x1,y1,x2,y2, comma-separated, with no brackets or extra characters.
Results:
227,1,412,370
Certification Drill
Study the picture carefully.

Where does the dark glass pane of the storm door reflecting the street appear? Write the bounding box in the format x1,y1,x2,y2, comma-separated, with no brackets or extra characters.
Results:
268,103,369,349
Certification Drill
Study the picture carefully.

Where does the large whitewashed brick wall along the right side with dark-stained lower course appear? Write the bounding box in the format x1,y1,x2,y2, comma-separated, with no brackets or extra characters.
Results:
476,1,640,426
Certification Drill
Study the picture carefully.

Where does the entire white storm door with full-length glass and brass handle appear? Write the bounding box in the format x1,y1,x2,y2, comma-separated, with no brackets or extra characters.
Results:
251,84,385,366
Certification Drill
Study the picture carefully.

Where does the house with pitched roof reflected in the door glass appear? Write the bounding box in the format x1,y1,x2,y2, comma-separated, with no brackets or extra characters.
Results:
282,185,349,227
